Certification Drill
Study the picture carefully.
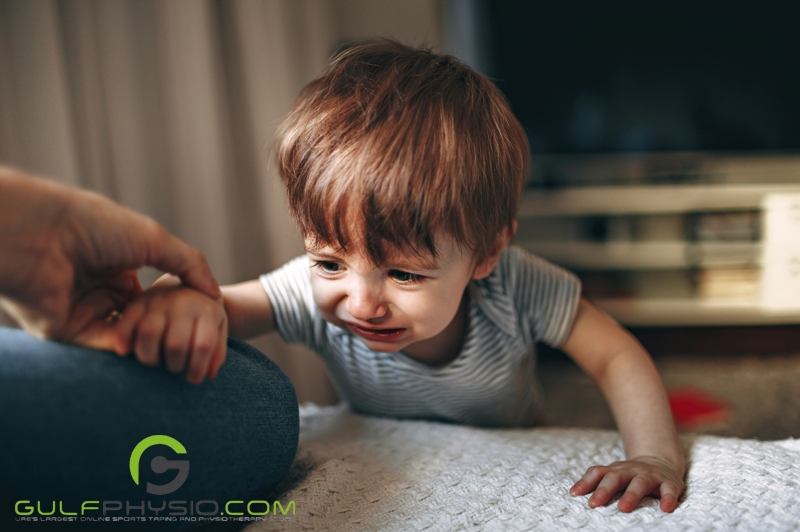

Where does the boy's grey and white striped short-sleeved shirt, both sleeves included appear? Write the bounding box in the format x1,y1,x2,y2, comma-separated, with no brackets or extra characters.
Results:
260,247,580,426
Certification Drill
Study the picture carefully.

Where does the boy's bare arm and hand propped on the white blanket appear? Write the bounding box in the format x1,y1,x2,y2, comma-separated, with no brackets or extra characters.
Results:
562,299,685,512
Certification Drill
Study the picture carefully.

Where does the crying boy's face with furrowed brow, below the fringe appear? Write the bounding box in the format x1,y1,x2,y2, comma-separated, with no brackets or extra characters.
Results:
306,238,476,362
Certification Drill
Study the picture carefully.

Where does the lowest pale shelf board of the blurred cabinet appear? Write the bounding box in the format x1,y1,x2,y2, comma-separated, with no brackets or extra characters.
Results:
593,299,800,327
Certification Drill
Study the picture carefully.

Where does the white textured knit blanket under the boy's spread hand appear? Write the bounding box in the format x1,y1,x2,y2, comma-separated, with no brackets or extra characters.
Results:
248,405,800,532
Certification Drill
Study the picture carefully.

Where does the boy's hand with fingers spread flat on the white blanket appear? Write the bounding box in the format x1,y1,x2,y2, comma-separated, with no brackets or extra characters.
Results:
569,456,684,512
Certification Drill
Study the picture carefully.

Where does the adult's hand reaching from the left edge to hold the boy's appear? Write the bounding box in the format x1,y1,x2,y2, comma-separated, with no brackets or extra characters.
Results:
0,167,221,348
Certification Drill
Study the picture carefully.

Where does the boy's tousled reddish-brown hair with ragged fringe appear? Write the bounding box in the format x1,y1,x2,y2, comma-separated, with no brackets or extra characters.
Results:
278,40,530,266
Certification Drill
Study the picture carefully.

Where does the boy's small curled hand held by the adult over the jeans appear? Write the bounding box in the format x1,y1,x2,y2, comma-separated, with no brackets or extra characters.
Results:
71,276,228,384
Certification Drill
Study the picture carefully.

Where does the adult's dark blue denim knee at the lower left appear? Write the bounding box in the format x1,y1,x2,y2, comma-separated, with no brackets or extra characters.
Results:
0,328,299,530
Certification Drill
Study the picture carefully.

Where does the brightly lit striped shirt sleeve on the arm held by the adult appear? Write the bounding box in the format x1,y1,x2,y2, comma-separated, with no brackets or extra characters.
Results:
258,255,317,348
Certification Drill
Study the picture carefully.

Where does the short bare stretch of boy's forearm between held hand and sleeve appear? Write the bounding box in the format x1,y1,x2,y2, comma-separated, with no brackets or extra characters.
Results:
222,279,275,340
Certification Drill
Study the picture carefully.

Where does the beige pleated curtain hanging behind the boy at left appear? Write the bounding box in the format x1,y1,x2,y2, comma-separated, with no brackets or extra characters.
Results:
0,0,440,404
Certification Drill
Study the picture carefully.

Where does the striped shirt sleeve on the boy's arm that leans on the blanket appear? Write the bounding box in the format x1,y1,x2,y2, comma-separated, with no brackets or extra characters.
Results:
501,247,581,347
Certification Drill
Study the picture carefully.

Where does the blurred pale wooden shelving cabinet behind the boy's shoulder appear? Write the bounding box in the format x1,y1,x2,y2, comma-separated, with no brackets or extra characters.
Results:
515,153,800,327
